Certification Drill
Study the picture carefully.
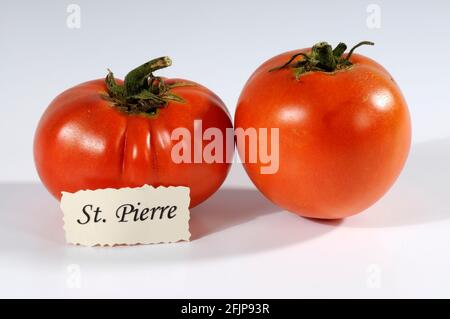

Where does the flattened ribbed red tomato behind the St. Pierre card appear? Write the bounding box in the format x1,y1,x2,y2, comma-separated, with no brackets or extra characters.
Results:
34,58,233,207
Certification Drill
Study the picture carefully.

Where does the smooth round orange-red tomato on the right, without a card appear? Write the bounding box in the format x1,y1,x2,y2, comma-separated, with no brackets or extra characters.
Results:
235,42,411,219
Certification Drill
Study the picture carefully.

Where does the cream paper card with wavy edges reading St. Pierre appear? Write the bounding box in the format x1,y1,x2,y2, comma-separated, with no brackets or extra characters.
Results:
61,185,191,246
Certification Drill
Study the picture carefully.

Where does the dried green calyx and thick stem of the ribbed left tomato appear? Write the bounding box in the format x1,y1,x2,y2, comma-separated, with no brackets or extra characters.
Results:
105,57,192,114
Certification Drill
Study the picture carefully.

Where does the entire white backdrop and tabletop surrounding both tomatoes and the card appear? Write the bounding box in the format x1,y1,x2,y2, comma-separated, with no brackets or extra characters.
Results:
0,0,450,297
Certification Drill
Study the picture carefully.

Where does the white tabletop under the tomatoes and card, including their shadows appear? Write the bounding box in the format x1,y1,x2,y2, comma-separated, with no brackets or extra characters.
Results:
0,139,450,298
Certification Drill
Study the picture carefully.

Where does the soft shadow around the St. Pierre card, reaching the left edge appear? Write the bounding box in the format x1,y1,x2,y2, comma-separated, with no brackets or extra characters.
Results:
0,183,335,267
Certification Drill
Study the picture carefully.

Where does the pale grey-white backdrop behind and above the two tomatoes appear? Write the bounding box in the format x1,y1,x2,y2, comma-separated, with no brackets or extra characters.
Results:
0,0,450,182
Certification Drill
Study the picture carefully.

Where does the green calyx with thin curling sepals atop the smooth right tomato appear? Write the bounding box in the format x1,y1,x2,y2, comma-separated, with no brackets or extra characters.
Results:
269,41,375,79
